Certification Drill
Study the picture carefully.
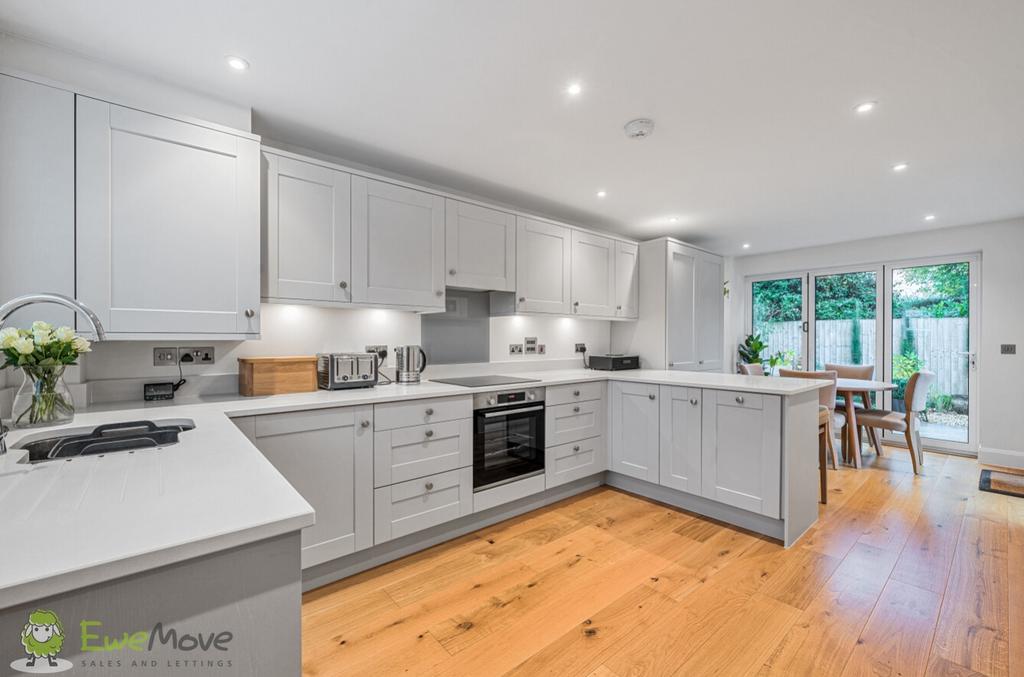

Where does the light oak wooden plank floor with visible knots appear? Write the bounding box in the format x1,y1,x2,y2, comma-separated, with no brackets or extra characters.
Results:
302,449,1024,677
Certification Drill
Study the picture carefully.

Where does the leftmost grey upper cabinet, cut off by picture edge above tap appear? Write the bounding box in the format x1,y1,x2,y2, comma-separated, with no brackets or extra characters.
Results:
0,75,76,329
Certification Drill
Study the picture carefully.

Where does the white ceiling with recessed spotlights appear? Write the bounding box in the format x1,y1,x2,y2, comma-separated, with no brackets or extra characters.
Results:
0,0,1024,254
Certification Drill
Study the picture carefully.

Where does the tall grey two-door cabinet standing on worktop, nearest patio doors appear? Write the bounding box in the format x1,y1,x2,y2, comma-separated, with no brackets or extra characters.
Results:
611,238,725,372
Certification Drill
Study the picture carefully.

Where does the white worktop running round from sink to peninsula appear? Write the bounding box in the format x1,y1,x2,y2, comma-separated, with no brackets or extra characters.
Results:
0,367,826,608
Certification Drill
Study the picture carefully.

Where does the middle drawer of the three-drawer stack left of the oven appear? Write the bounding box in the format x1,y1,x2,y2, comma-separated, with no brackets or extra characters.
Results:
374,419,473,486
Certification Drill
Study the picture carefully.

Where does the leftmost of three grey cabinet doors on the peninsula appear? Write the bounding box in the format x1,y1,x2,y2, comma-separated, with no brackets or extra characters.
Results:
608,382,660,483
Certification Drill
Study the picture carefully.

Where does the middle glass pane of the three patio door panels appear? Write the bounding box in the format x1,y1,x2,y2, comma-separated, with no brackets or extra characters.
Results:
814,272,878,368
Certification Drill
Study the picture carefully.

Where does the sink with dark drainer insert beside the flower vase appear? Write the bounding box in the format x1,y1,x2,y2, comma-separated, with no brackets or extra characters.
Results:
14,419,196,463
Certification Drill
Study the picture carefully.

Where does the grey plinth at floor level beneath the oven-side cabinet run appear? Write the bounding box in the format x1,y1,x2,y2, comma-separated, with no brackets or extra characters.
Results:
302,473,604,592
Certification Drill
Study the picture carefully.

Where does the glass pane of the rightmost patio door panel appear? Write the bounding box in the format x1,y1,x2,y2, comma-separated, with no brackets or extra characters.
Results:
892,262,971,443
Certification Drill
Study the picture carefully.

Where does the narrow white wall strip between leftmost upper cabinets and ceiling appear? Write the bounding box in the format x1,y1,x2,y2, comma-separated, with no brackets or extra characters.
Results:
0,33,252,131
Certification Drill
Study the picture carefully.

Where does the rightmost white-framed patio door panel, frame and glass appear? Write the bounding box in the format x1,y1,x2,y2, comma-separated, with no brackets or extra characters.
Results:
885,255,981,454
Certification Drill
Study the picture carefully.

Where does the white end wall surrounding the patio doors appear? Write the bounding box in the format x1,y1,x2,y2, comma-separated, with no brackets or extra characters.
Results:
726,219,1024,467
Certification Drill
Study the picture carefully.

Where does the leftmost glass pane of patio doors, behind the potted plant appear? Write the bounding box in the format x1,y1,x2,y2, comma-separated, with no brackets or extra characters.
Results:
751,277,806,366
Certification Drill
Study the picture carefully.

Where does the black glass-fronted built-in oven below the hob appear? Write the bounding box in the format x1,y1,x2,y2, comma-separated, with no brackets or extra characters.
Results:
473,388,544,492
